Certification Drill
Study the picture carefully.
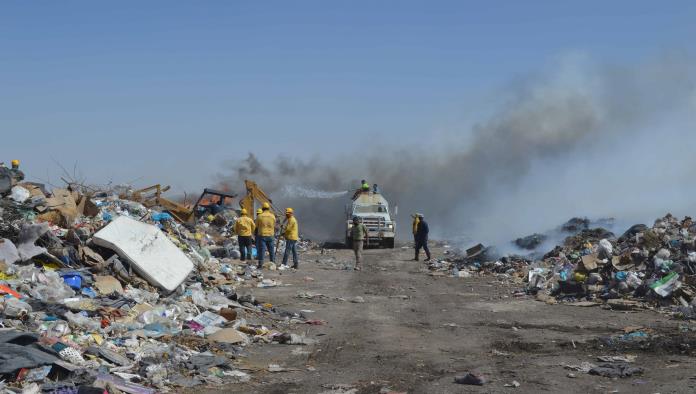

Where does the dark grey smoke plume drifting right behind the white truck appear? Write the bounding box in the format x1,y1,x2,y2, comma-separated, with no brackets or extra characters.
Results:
220,56,696,242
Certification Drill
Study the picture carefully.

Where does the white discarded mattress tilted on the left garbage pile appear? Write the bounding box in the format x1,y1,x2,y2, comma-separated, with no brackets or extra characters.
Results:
92,216,193,291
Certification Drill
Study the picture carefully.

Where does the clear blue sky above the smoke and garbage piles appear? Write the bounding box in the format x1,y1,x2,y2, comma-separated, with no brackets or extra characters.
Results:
0,1,696,190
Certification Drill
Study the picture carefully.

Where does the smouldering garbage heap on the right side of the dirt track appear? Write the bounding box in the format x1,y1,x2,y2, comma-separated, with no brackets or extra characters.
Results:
429,214,696,319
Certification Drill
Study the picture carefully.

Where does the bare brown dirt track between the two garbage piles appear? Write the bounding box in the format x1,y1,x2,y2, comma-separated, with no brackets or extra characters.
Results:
197,245,696,394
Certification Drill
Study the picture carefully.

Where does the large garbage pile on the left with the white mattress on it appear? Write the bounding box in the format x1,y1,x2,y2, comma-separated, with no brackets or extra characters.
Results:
0,183,313,393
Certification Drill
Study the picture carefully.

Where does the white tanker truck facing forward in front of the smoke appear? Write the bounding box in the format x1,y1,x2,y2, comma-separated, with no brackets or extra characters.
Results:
346,191,396,248
